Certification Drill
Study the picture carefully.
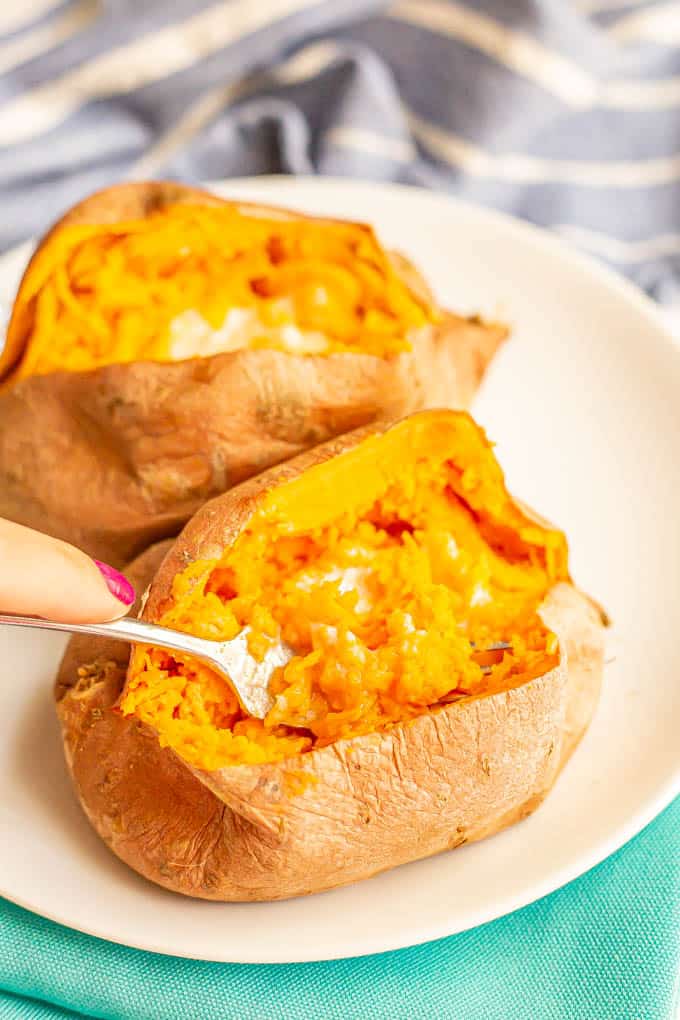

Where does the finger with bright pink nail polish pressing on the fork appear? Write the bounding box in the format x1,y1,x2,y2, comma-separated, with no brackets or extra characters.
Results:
0,519,135,623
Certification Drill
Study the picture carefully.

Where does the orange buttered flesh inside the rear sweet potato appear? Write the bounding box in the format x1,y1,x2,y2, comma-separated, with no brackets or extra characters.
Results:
3,203,433,378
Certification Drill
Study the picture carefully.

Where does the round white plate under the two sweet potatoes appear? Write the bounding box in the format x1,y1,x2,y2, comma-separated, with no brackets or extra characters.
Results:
0,179,680,962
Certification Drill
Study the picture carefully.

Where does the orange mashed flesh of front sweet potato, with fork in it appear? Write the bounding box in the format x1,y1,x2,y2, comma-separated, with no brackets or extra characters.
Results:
120,412,568,770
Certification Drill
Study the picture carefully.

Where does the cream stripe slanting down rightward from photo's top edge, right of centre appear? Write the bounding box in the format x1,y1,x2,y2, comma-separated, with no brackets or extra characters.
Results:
385,0,597,108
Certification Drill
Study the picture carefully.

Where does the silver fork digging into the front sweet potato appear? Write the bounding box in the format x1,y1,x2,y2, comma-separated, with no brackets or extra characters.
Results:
0,613,510,719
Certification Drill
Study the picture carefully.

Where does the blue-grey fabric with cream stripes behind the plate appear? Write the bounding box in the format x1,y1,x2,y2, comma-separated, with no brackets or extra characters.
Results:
0,0,680,302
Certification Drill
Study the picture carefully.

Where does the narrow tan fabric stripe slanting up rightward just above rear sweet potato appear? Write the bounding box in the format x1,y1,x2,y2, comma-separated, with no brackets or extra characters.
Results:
127,42,343,181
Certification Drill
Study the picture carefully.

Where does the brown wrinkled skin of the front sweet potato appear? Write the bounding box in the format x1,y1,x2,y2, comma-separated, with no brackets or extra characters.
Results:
57,414,604,901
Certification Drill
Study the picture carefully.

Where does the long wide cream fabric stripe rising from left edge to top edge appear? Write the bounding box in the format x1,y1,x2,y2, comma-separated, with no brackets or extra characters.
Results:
0,0,318,145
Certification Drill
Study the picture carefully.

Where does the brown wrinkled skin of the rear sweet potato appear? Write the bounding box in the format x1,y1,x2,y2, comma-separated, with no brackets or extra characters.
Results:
0,182,507,566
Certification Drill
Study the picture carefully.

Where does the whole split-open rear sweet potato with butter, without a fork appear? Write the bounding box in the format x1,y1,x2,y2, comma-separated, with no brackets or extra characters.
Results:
0,183,507,565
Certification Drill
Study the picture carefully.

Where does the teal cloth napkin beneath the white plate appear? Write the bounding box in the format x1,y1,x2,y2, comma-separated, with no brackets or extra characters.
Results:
0,799,680,1020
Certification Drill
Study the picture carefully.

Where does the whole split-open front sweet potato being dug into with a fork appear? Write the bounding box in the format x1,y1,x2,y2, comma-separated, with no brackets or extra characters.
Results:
57,411,604,901
